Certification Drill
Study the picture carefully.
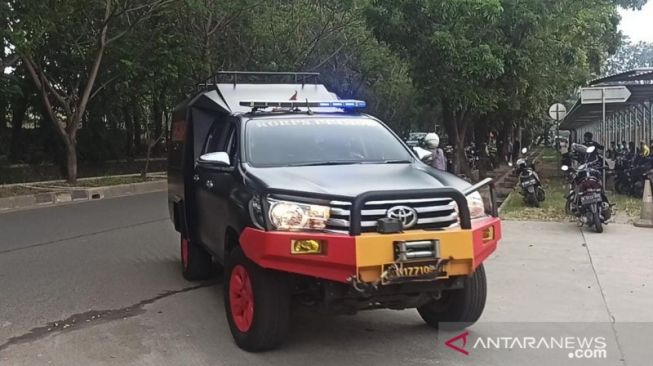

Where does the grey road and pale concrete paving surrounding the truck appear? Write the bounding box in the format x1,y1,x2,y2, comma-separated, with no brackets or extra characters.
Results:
0,193,653,366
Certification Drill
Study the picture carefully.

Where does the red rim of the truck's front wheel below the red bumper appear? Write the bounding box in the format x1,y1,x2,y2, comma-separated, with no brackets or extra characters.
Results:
229,264,254,333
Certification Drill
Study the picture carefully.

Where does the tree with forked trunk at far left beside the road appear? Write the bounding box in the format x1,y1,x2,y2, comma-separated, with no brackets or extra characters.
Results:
10,0,169,183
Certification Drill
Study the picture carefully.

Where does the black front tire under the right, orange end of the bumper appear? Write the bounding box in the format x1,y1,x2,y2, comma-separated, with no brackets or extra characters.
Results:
417,264,487,329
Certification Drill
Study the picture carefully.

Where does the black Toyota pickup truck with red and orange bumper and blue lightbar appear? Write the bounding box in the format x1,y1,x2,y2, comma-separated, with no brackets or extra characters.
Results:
168,72,501,351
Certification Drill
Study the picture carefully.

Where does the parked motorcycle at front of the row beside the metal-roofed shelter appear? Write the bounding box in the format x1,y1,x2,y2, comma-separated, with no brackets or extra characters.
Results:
561,144,612,233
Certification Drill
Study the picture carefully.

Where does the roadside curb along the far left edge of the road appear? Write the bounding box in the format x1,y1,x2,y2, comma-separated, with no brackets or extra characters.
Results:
0,180,168,213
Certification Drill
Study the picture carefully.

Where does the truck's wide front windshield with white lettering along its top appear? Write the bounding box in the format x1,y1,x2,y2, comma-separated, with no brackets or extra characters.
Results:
245,118,412,167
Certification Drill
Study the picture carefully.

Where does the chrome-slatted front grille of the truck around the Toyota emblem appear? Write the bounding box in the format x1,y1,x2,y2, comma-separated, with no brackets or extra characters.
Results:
326,198,458,233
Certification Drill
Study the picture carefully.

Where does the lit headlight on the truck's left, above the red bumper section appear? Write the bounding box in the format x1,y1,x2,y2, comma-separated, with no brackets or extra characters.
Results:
269,200,330,231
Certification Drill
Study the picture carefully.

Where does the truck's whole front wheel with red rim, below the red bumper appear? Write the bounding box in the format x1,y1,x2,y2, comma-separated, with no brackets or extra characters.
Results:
224,248,290,352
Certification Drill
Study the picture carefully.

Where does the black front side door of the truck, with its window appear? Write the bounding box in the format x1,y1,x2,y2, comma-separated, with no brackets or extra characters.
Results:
193,119,239,259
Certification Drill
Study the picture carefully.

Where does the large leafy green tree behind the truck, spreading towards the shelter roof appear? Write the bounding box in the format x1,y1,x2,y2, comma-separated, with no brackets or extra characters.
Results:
367,0,645,174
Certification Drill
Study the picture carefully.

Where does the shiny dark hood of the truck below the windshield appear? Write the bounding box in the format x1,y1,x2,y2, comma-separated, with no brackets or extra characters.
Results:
244,163,470,197
